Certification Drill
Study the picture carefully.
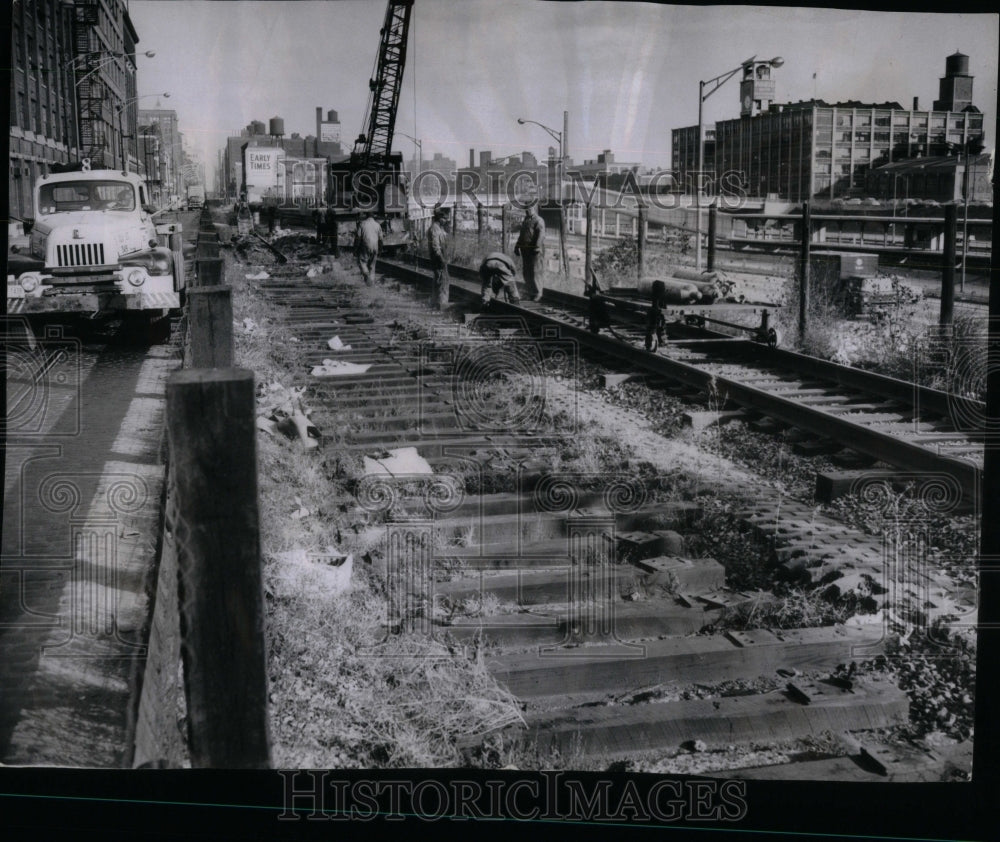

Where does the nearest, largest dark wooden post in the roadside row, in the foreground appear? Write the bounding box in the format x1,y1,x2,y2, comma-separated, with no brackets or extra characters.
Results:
167,368,270,769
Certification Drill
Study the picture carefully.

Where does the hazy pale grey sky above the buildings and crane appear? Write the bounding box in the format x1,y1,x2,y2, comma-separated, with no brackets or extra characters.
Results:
129,0,1000,184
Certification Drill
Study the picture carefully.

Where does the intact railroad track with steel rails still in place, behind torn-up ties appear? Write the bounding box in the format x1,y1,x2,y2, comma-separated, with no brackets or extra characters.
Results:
382,253,985,501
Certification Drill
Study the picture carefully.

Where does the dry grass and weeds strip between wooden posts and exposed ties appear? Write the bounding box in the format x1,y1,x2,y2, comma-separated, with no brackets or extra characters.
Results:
227,244,521,768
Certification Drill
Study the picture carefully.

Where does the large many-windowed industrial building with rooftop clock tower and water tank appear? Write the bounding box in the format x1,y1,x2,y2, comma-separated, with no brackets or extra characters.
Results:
672,54,983,201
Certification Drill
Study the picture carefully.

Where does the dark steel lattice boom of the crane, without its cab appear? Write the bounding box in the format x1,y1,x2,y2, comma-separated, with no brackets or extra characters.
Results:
351,0,413,170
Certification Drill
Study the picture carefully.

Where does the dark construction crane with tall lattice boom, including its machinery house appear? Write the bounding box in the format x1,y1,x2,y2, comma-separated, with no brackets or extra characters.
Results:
331,0,413,243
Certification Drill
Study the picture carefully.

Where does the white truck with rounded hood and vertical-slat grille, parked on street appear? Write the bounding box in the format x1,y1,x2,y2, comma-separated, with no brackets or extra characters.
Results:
7,167,184,314
